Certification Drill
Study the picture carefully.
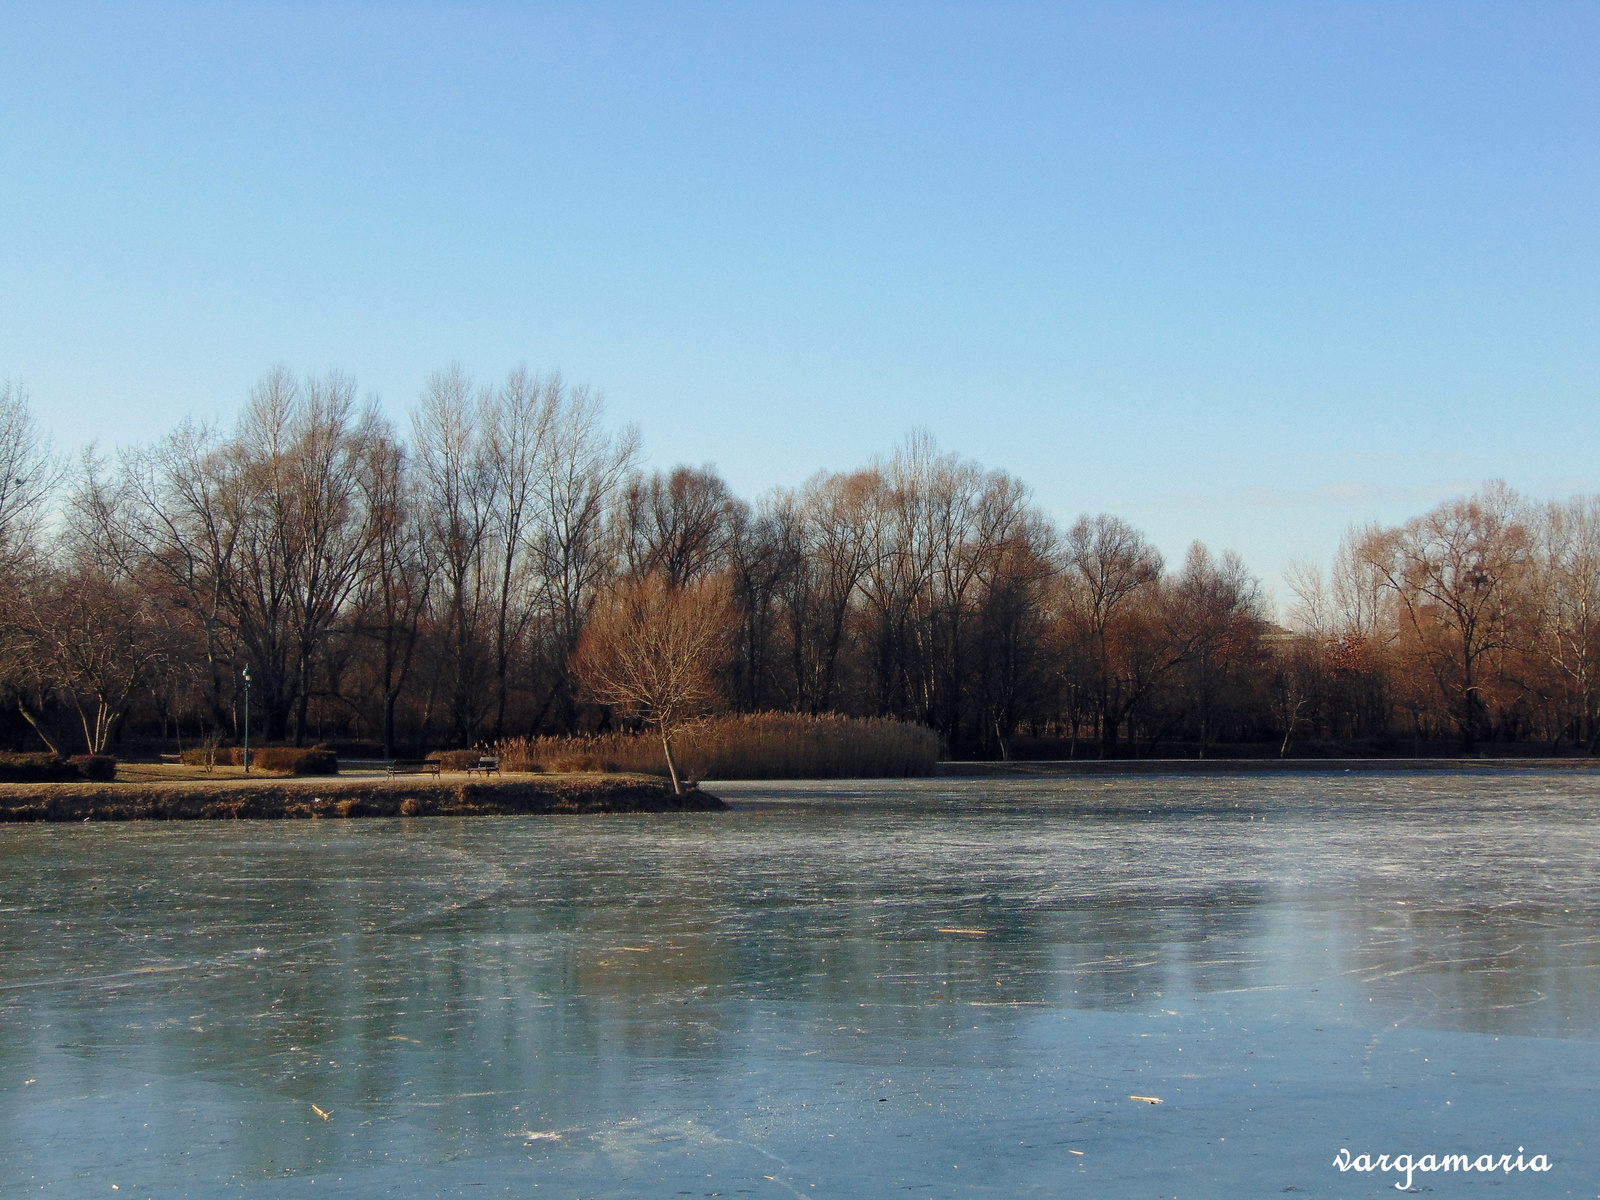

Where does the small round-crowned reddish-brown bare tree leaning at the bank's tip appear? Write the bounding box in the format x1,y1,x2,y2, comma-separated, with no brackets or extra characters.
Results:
573,573,733,795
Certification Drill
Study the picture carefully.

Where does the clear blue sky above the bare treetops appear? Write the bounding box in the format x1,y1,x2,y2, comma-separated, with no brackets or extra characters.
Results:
0,3,1600,594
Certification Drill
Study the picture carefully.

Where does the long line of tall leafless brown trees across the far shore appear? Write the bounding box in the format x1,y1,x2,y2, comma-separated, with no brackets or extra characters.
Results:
0,368,1600,757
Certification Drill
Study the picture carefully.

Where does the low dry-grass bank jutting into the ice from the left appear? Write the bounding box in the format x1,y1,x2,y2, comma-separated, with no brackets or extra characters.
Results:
0,778,726,822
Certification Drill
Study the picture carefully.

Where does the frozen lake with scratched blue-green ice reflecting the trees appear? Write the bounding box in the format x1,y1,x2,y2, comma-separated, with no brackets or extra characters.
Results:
0,771,1600,1200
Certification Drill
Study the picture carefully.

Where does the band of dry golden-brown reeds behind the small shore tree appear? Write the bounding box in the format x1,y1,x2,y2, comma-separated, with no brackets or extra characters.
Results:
496,712,939,779
